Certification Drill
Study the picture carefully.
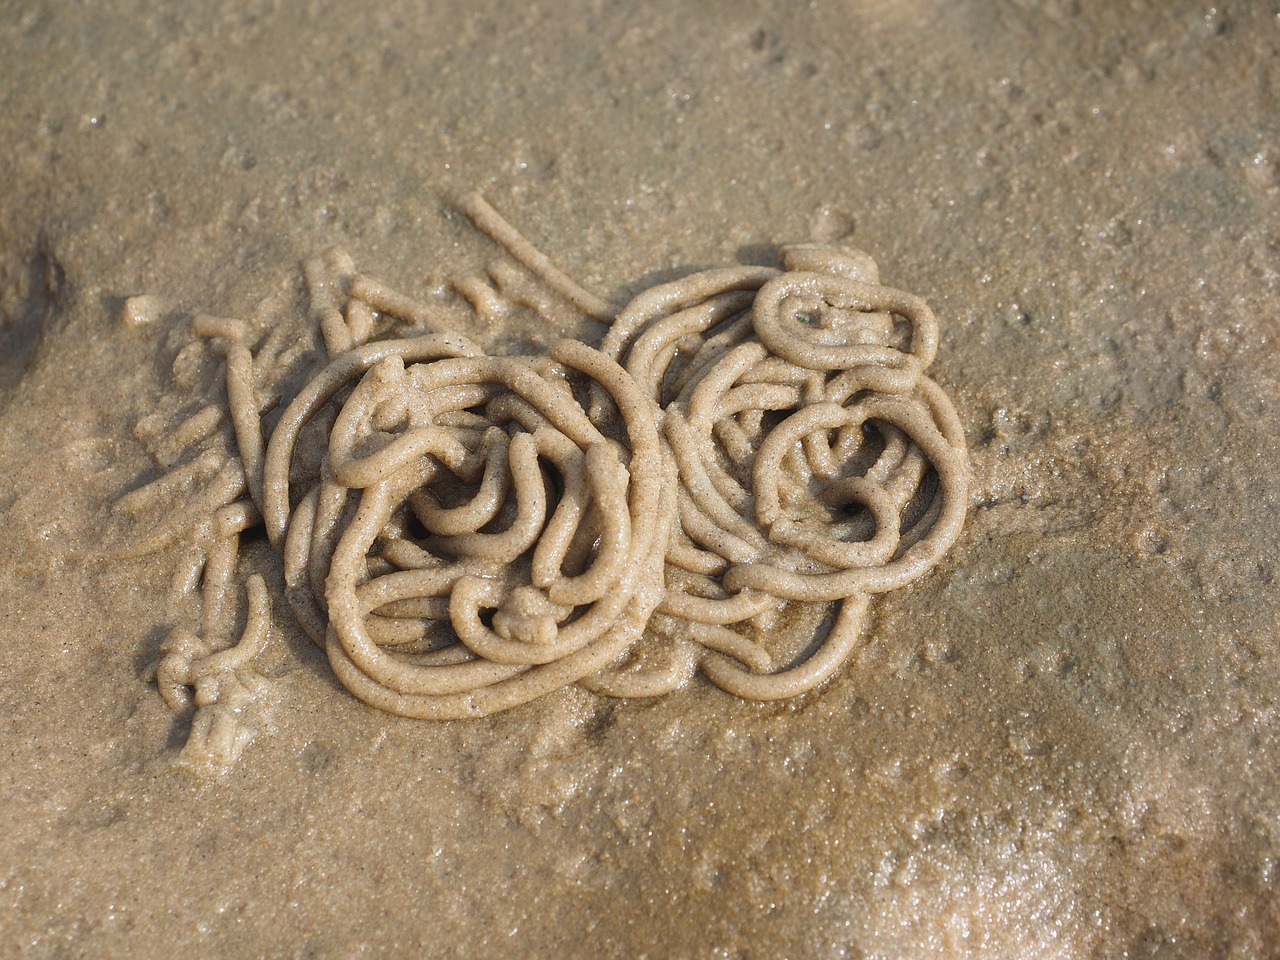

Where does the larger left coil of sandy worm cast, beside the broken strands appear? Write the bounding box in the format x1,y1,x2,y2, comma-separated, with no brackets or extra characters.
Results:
268,342,672,718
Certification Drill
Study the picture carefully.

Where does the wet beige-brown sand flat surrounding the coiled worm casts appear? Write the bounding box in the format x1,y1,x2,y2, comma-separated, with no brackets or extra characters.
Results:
0,0,1280,959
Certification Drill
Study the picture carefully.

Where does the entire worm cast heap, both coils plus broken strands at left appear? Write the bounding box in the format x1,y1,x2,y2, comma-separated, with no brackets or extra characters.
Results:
122,195,969,737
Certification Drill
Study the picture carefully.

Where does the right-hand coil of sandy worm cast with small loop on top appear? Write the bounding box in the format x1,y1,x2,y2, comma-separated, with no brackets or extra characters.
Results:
591,244,968,699
